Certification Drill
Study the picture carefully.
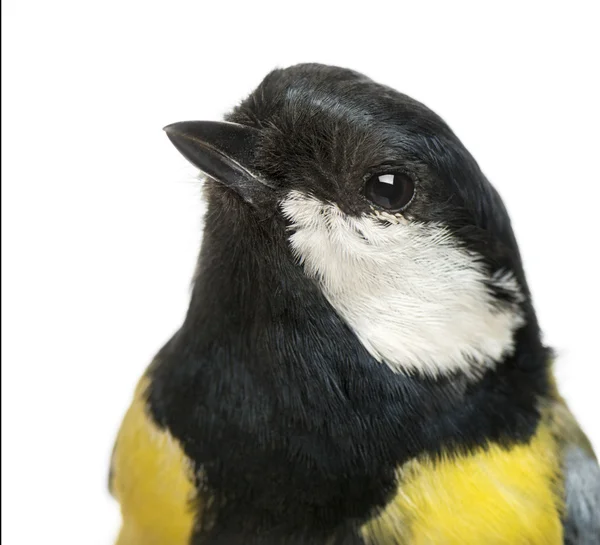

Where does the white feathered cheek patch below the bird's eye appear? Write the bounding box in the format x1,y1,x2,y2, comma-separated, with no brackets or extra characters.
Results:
281,191,524,376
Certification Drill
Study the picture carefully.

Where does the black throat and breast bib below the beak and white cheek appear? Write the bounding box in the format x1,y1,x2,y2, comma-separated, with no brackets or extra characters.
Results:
148,186,548,543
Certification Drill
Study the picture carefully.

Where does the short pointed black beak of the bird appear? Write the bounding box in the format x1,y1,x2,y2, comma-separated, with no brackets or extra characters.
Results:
164,121,272,203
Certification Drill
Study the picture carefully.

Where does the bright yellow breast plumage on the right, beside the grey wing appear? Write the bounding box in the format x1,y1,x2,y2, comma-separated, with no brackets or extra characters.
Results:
362,425,563,545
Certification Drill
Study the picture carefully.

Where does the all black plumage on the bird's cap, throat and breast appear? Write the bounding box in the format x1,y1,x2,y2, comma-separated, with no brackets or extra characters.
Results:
148,65,549,545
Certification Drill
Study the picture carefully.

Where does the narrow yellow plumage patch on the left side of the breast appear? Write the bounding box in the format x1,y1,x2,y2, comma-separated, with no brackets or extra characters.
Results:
112,378,194,545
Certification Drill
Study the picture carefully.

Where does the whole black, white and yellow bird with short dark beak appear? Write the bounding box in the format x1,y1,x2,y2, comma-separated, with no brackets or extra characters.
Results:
109,63,600,545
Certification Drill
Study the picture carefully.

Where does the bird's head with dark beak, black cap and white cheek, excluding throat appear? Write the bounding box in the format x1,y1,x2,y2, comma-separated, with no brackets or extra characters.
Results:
165,64,538,376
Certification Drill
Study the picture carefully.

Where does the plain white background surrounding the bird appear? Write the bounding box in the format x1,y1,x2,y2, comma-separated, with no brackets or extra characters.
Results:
2,0,600,545
